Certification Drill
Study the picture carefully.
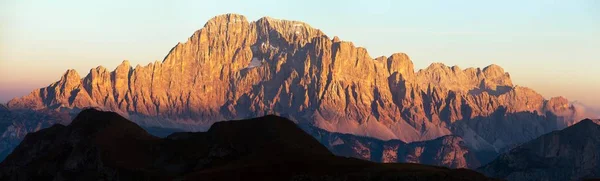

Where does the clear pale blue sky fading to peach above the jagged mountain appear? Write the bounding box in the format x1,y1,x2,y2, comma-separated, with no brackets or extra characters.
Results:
0,0,600,109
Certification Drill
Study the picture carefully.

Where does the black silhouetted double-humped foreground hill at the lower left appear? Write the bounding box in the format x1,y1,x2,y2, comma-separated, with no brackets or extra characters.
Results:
0,109,491,180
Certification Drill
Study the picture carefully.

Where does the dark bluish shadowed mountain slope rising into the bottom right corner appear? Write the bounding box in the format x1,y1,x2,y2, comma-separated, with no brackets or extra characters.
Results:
479,119,600,181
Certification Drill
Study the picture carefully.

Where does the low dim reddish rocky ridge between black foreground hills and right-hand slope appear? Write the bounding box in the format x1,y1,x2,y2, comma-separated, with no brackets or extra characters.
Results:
304,127,497,168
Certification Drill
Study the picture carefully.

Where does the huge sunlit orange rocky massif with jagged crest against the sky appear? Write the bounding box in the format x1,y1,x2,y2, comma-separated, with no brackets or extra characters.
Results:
8,14,576,149
